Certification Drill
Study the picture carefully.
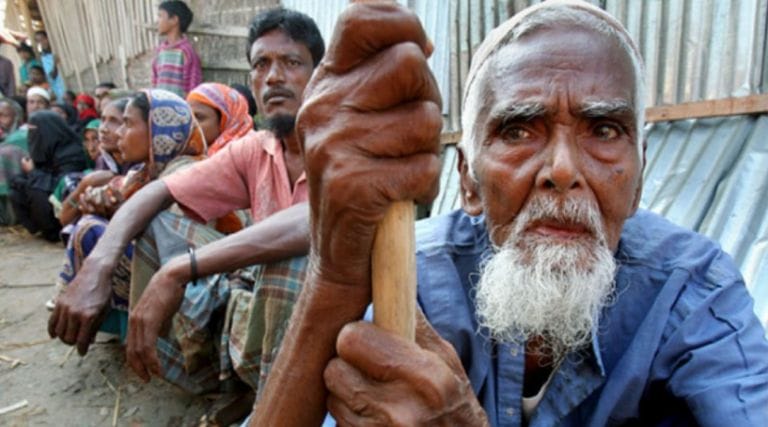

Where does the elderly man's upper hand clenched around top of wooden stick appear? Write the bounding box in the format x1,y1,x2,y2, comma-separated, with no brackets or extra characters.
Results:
297,4,442,286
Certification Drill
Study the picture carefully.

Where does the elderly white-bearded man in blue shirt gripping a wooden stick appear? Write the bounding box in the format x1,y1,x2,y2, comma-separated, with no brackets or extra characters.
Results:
251,0,768,426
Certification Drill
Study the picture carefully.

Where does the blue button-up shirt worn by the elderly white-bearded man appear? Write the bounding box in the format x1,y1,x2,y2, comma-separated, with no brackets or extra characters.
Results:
416,211,768,426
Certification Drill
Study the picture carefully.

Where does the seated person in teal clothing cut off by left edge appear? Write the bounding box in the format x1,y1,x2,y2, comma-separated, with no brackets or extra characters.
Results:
0,98,29,225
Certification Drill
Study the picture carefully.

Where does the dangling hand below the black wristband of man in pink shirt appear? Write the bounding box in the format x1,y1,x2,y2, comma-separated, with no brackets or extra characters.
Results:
126,263,184,382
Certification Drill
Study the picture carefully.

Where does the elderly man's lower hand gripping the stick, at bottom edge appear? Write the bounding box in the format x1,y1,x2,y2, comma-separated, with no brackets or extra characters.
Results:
324,312,488,426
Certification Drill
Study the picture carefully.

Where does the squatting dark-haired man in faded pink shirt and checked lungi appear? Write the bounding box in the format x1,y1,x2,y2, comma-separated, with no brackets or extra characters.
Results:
49,9,325,392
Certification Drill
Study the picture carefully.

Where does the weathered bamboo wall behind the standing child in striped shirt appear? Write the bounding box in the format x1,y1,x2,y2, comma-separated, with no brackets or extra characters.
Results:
33,0,279,91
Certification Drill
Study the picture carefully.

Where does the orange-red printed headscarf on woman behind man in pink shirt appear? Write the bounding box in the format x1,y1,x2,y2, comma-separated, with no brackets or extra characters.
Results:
187,83,253,156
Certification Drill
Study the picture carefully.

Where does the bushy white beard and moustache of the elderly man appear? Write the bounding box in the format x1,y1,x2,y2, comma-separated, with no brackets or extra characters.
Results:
475,197,616,360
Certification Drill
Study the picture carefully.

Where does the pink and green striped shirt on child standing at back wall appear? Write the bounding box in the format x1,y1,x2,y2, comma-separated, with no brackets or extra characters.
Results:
152,36,203,98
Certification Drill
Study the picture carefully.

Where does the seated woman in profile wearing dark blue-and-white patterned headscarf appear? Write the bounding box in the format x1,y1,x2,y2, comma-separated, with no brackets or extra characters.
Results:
53,89,205,338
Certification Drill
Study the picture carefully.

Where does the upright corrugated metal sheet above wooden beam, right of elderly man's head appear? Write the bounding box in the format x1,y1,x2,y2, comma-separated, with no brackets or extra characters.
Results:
604,0,768,105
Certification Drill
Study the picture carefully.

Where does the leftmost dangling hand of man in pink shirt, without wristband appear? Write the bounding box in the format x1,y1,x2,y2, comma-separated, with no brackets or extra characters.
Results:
48,259,114,356
